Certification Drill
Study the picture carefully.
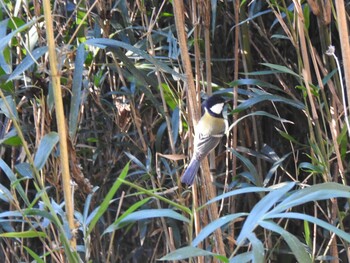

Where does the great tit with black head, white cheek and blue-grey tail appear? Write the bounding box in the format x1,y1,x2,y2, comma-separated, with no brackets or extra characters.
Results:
181,95,226,185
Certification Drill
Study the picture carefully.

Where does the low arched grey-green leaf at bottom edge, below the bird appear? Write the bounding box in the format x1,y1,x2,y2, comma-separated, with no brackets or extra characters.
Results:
159,246,229,263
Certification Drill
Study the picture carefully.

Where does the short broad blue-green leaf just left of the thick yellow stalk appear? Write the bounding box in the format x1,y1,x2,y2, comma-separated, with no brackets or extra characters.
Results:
34,132,59,171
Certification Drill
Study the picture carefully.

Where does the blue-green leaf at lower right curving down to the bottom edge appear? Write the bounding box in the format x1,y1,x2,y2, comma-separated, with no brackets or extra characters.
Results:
259,220,312,263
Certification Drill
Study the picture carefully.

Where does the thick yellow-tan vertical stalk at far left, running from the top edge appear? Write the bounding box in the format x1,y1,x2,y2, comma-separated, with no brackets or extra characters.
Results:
43,0,76,250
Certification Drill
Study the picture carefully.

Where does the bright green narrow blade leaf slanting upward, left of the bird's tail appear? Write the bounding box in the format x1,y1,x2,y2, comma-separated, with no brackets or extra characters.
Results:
87,163,129,236
